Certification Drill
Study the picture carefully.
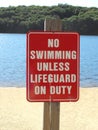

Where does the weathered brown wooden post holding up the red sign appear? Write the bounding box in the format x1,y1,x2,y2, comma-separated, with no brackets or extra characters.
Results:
43,19,62,130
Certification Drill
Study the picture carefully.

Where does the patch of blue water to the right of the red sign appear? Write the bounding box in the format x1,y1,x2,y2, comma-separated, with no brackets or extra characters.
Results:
80,36,98,87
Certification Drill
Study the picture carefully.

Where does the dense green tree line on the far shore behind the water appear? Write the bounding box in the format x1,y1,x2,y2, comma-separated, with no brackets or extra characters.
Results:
0,4,98,35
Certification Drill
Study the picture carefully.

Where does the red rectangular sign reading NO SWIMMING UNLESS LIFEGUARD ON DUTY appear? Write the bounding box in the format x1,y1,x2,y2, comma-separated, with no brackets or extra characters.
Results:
26,32,80,102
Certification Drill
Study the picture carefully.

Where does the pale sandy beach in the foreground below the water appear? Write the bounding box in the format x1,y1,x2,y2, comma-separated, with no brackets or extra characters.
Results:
0,87,98,130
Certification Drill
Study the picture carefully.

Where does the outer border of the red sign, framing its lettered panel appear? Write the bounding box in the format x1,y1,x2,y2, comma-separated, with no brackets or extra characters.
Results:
26,31,80,102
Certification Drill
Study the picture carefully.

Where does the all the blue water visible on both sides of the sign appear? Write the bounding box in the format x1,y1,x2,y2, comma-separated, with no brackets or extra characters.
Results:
0,34,98,87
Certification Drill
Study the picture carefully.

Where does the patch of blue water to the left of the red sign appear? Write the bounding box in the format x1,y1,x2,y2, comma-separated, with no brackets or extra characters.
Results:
0,34,26,87
